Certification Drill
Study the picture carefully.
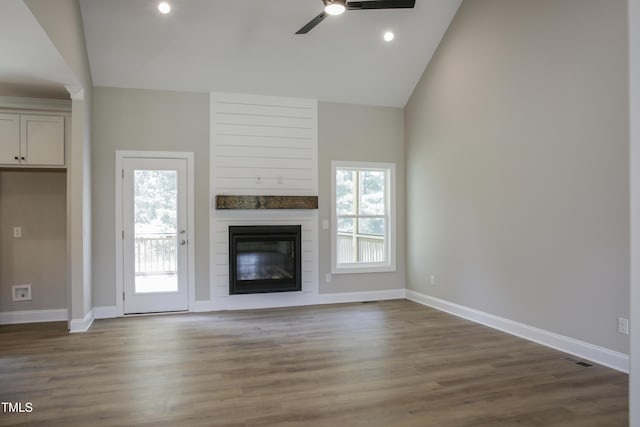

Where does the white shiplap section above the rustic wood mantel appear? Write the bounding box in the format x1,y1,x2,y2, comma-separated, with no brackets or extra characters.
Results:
211,93,318,196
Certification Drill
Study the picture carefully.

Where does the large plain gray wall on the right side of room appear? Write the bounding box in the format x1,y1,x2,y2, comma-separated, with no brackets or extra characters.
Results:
405,0,629,353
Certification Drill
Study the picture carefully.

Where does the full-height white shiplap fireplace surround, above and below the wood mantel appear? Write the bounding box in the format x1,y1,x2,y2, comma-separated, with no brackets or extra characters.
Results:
210,93,318,309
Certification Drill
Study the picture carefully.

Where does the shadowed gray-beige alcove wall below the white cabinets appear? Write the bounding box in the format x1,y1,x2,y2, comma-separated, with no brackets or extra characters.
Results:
0,170,67,312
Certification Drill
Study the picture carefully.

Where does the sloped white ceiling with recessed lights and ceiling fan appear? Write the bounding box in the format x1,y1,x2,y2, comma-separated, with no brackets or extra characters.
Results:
80,0,460,107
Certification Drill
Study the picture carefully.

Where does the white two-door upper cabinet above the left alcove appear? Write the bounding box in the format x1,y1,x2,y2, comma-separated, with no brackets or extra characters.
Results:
0,114,64,166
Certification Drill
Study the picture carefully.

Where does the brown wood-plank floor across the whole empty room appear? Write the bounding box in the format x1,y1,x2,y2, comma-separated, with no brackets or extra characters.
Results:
0,300,628,427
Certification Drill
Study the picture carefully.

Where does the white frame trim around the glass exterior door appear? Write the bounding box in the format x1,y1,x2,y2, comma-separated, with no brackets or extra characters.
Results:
115,150,196,316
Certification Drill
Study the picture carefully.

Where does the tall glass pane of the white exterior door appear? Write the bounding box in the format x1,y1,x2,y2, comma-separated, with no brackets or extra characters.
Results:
133,170,178,293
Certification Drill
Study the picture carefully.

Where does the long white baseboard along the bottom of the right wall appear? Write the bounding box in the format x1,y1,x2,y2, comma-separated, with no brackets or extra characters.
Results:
406,289,629,373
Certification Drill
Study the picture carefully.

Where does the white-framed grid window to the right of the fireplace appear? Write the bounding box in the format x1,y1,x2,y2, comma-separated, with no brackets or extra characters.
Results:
331,161,396,274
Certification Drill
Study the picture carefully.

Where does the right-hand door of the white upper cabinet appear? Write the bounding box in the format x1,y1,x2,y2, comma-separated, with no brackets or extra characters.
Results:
20,116,64,165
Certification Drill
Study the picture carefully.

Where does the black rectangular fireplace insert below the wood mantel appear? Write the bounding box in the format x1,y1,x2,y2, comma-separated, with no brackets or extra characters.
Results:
229,225,302,295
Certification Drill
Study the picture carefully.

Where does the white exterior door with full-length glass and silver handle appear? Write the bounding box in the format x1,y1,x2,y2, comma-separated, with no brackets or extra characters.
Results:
122,158,188,313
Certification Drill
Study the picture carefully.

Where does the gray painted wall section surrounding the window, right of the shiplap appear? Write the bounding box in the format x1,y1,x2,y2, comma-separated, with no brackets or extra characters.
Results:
318,102,406,293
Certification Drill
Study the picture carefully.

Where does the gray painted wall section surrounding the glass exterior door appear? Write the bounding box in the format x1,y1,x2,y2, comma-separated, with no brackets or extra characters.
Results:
92,87,209,307
